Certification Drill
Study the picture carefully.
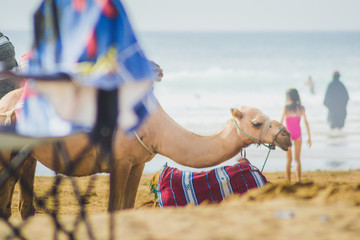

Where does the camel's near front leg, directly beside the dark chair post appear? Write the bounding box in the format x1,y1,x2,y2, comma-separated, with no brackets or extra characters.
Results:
108,161,132,212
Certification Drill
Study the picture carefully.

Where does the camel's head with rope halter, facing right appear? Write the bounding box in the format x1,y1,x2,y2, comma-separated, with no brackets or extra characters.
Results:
230,106,291,151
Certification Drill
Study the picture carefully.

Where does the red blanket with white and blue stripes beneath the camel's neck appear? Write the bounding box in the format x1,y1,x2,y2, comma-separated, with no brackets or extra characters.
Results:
158,158,267,207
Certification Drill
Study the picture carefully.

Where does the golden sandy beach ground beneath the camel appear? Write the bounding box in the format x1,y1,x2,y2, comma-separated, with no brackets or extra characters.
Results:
0,170,360,240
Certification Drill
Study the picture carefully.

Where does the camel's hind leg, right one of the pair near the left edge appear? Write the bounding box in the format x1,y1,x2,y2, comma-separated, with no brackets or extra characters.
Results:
19,157,36,219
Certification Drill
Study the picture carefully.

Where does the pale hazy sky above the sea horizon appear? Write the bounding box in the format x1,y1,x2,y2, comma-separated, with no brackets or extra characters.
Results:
0,0,360,31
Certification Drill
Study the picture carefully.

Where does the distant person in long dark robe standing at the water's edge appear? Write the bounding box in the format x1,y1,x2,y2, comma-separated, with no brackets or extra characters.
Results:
324,71,349,129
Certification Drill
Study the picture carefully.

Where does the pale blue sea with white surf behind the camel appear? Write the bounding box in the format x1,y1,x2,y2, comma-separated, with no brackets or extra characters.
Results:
4,31,360,176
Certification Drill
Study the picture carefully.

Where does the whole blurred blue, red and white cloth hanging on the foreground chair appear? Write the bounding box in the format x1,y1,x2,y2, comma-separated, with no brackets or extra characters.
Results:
2,0,157,142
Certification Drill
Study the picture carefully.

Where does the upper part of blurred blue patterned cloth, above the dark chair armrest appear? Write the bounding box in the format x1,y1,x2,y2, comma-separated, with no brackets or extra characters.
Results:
27,0,154,90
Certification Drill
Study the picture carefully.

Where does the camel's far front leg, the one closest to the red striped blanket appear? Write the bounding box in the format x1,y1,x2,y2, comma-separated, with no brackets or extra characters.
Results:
121,163,145,209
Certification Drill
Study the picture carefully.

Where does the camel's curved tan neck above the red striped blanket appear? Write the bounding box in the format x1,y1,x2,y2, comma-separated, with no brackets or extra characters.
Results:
153,108,245,168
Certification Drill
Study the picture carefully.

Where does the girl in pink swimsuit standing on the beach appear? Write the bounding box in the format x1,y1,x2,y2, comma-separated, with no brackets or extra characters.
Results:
280,88,311,182
